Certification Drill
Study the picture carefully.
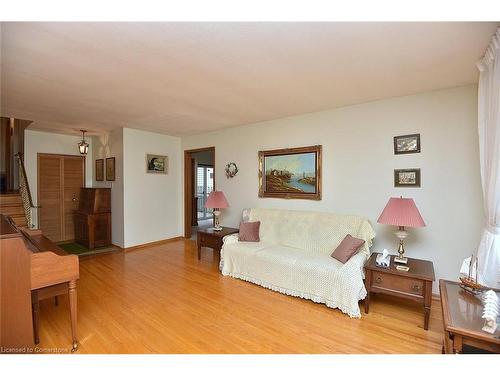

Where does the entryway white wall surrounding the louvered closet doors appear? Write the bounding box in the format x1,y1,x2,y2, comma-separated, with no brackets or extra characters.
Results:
24,129,93,226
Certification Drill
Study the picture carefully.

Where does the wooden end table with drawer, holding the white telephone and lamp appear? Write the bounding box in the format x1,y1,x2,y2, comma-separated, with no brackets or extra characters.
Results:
365,253,434,330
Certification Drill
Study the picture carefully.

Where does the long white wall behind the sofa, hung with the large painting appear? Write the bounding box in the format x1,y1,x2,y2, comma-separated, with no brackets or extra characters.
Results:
181,86,483,292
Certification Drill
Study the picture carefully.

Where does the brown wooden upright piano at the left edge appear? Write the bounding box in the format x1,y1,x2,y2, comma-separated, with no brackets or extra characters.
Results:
0,214,79,353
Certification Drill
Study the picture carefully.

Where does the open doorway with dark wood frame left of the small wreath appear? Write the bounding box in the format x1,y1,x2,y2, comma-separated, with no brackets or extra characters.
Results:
184,147,215,238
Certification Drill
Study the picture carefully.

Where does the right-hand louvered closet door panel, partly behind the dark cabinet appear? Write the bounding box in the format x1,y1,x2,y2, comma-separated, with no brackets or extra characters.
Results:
63,156,84,241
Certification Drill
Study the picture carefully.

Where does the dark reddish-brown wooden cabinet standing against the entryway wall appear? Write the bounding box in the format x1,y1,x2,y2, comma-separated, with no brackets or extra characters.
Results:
74,188,111,249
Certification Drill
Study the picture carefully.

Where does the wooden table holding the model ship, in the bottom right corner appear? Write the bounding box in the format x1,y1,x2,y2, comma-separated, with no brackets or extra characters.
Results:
439,280,500,353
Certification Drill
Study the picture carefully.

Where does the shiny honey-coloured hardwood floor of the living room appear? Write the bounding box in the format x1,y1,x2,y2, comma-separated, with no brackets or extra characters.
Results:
40,240,443,353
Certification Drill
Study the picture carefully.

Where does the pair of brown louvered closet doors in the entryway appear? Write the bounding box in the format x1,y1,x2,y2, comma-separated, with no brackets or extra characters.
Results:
38,154,85,242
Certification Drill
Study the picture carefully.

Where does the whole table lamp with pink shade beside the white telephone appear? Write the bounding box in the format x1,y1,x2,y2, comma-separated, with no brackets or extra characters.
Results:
377,197,425,264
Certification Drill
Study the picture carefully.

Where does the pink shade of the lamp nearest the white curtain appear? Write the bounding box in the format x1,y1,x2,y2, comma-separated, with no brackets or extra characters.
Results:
377,198,425,227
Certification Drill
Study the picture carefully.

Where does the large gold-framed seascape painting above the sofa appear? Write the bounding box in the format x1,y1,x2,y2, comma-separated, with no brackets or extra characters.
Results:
259,146,321,200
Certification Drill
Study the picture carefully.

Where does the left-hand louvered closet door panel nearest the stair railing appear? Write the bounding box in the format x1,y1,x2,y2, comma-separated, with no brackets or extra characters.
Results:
38,155,63,242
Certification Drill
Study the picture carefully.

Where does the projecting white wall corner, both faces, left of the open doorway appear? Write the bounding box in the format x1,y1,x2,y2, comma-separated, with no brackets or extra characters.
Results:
92,128,183,248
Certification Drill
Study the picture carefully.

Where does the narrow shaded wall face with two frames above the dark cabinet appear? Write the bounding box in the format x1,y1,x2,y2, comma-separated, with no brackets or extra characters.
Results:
92,128,125,247
